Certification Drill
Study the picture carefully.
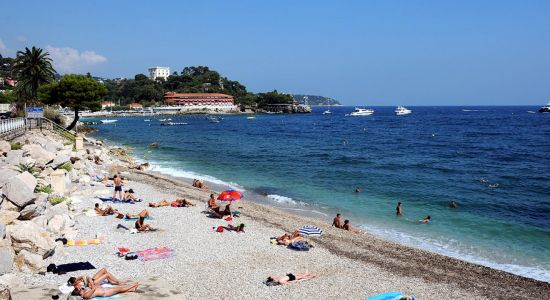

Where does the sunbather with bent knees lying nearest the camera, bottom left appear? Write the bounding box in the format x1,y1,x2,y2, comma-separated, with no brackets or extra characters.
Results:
67,268,139,299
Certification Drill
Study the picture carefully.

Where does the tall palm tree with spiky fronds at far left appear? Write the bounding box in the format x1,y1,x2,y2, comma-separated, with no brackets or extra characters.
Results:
14,46,55,101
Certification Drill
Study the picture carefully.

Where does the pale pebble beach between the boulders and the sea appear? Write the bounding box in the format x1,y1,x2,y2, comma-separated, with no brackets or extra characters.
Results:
0,130,550,299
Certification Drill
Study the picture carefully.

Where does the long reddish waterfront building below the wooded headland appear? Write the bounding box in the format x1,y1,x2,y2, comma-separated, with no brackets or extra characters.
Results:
164,93,234,106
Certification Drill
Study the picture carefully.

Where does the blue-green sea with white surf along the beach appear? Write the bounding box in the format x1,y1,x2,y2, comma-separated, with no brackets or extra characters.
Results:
88,106,550,282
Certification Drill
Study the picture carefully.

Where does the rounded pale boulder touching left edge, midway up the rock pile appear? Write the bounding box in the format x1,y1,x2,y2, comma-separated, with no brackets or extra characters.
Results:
2,172,37,208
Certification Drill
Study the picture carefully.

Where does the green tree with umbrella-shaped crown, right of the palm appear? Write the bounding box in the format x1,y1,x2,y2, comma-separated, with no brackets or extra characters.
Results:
40,74,107,130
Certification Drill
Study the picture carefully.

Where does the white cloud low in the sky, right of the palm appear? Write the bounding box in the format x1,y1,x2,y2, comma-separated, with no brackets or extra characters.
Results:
46,46,107,73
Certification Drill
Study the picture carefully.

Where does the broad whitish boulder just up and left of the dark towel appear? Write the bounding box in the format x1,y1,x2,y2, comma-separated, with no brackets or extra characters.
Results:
6,221,55,258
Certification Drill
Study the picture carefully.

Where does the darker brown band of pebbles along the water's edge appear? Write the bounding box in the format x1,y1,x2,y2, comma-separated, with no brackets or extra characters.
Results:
127,171,550,299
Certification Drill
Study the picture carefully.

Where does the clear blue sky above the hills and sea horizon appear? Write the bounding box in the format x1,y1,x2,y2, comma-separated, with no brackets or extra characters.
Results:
0,0,550,105
